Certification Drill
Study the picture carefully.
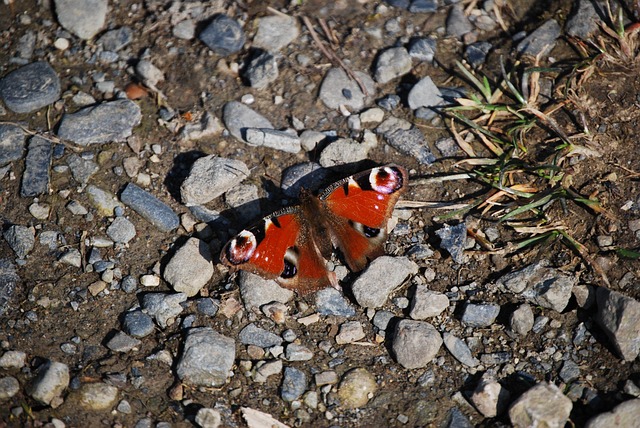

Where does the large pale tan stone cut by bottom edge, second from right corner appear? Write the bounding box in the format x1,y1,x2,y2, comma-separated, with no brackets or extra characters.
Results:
509,382,573,428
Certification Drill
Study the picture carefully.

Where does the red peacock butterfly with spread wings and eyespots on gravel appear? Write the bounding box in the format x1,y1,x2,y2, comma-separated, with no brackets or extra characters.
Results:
220,164,409,295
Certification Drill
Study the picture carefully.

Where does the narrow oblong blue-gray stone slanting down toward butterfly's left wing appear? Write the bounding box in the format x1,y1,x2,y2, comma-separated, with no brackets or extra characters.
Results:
120,183,180,232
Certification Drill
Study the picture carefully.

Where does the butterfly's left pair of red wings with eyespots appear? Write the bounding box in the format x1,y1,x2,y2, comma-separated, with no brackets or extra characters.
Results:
220,207,335,294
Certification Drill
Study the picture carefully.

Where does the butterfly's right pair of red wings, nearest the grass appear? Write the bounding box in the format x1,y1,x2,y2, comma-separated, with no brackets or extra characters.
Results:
320,165,409,271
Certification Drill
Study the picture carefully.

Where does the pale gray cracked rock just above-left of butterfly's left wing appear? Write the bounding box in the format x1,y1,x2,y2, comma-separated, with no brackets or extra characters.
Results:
180,155,249,206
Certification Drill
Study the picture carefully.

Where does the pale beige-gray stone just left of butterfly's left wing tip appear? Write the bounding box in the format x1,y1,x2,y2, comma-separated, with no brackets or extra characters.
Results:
163,238,213,297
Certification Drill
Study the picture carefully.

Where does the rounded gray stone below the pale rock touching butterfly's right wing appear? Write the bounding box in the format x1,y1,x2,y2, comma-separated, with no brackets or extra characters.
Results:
392,320,442,369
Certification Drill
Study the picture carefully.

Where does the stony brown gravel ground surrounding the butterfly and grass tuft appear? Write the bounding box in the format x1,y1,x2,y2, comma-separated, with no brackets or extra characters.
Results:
0,0,640,428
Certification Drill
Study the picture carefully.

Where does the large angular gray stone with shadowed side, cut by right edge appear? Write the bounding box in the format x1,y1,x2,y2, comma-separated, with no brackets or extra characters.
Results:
596,287,640,361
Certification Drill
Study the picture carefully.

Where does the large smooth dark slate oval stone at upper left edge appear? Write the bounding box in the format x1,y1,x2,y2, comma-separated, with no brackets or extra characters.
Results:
0,62,60,113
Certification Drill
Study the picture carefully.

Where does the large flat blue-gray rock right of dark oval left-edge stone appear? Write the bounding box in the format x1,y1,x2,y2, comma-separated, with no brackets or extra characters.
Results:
58,99,142,146
